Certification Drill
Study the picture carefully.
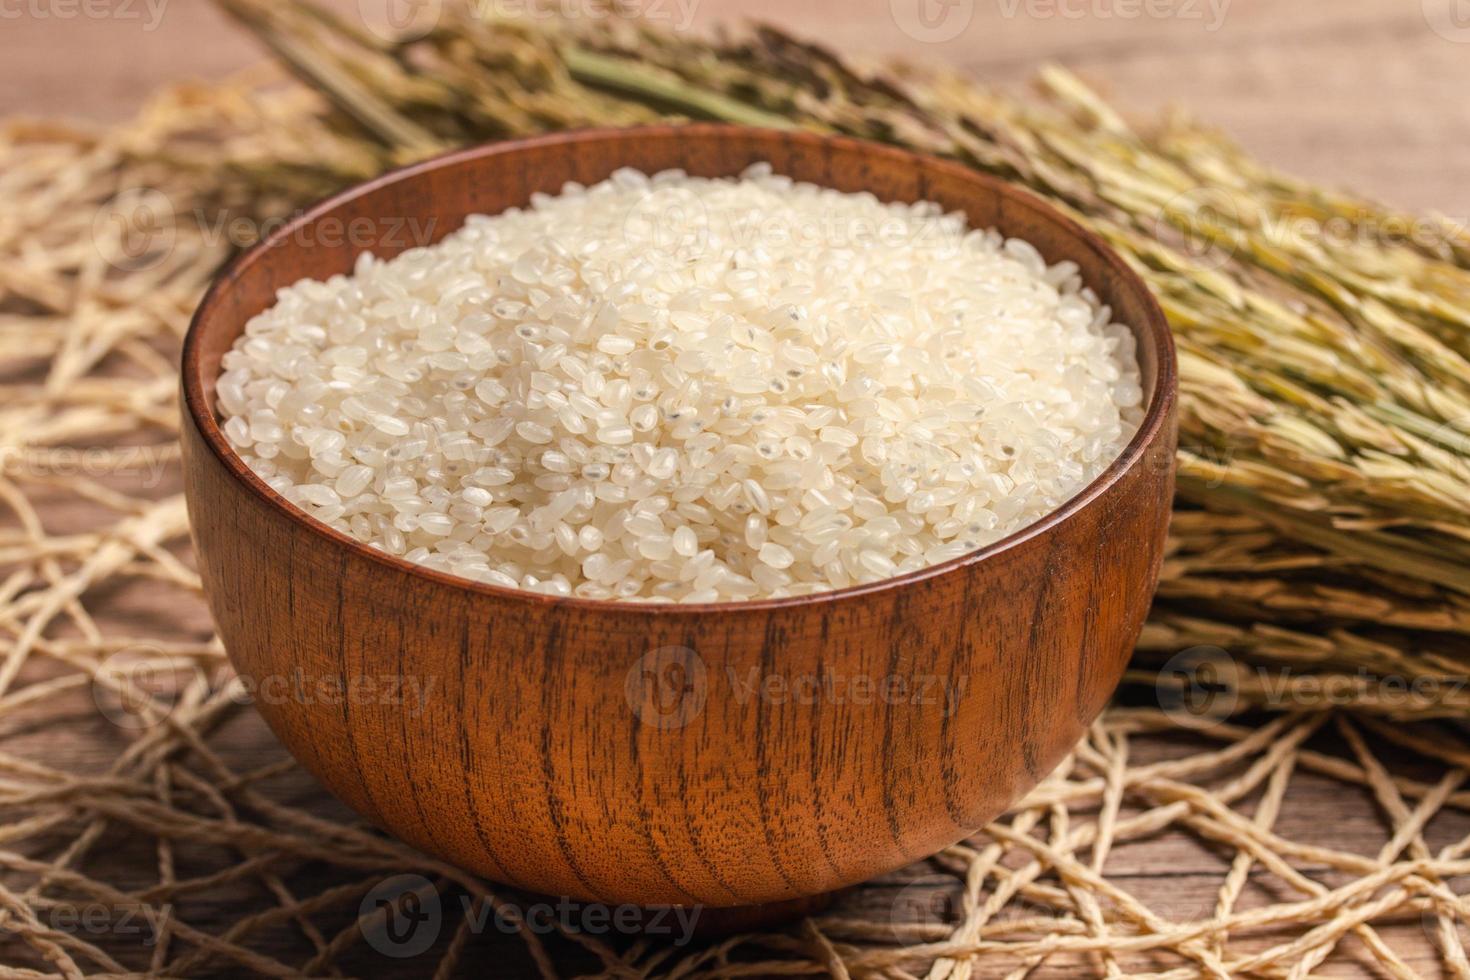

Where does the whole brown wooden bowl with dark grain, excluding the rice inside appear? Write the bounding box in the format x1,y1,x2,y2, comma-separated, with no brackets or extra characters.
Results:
182,125,1177,907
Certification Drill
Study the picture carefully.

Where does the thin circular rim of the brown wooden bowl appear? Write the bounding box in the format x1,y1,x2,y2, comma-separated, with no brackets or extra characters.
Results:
181,122,1179,616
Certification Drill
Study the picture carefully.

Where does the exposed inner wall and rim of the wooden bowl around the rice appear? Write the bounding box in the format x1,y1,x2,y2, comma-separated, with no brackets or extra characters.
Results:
182,123,1176,611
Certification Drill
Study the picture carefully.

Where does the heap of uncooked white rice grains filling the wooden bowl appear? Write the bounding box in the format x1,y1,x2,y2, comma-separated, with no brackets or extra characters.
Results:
218,166,1142,602
